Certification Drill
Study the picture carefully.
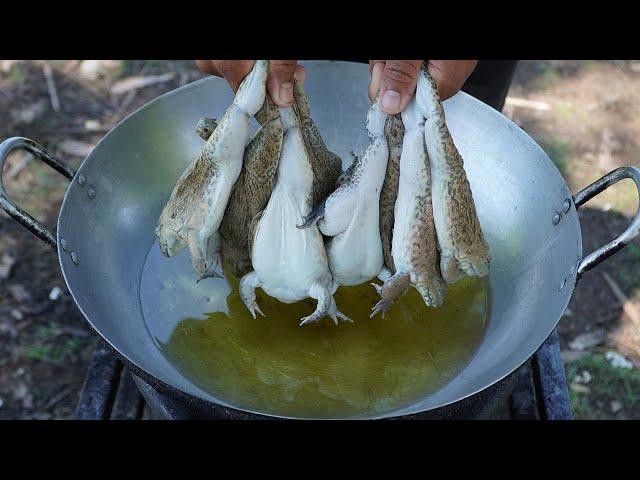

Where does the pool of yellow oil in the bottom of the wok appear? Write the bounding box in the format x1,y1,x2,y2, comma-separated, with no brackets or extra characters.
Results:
162,268,488,418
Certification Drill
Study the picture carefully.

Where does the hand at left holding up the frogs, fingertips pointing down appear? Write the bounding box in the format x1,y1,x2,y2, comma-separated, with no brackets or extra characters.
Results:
196,60,307,108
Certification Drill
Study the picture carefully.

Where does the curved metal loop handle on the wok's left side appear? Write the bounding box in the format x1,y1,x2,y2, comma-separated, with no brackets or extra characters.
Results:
0,137,76,249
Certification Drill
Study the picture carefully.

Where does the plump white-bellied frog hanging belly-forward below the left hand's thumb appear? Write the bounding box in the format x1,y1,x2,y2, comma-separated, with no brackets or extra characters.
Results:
239,94,352,326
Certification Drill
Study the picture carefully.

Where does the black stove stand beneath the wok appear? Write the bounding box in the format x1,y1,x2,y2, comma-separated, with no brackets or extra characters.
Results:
76,331,572,420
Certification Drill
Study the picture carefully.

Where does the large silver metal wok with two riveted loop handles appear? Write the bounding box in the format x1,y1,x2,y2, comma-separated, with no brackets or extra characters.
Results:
0,61,640,417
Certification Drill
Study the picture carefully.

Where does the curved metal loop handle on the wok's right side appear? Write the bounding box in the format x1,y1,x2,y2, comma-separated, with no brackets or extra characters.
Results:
573,167,640,280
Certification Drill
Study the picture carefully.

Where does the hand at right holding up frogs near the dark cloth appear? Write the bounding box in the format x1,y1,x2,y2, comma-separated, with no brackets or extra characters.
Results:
369,60,478,115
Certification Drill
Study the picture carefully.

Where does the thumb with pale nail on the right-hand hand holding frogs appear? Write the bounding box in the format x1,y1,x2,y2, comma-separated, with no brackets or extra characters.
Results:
381,60,422,115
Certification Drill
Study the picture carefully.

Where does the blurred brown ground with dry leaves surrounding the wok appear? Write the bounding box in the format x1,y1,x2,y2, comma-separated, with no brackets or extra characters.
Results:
0,60,640,419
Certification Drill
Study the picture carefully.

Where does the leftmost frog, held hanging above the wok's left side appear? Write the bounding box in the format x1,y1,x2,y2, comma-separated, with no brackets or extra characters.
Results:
156,60,269,281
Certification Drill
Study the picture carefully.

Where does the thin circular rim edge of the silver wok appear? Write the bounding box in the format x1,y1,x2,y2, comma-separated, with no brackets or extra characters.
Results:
56,66,583,421
